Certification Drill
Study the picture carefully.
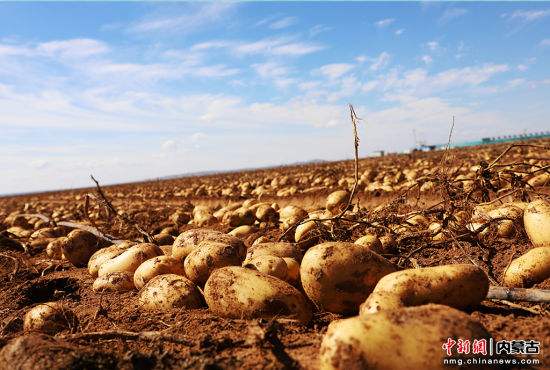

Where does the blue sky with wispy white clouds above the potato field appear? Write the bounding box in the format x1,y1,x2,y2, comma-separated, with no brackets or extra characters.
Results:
0,2,550,194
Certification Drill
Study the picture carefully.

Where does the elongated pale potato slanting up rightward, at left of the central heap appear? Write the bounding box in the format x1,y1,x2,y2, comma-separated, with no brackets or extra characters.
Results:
98,243,163,276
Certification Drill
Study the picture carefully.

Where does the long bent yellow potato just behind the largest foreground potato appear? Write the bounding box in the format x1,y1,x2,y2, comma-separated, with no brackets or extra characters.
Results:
360,264,489,315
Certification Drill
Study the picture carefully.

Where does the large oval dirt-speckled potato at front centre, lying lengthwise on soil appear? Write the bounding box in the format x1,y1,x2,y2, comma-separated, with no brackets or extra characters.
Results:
204,266,312,322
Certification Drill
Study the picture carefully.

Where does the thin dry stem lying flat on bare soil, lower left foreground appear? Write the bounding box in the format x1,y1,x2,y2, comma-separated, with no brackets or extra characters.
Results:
58,330,194,346
